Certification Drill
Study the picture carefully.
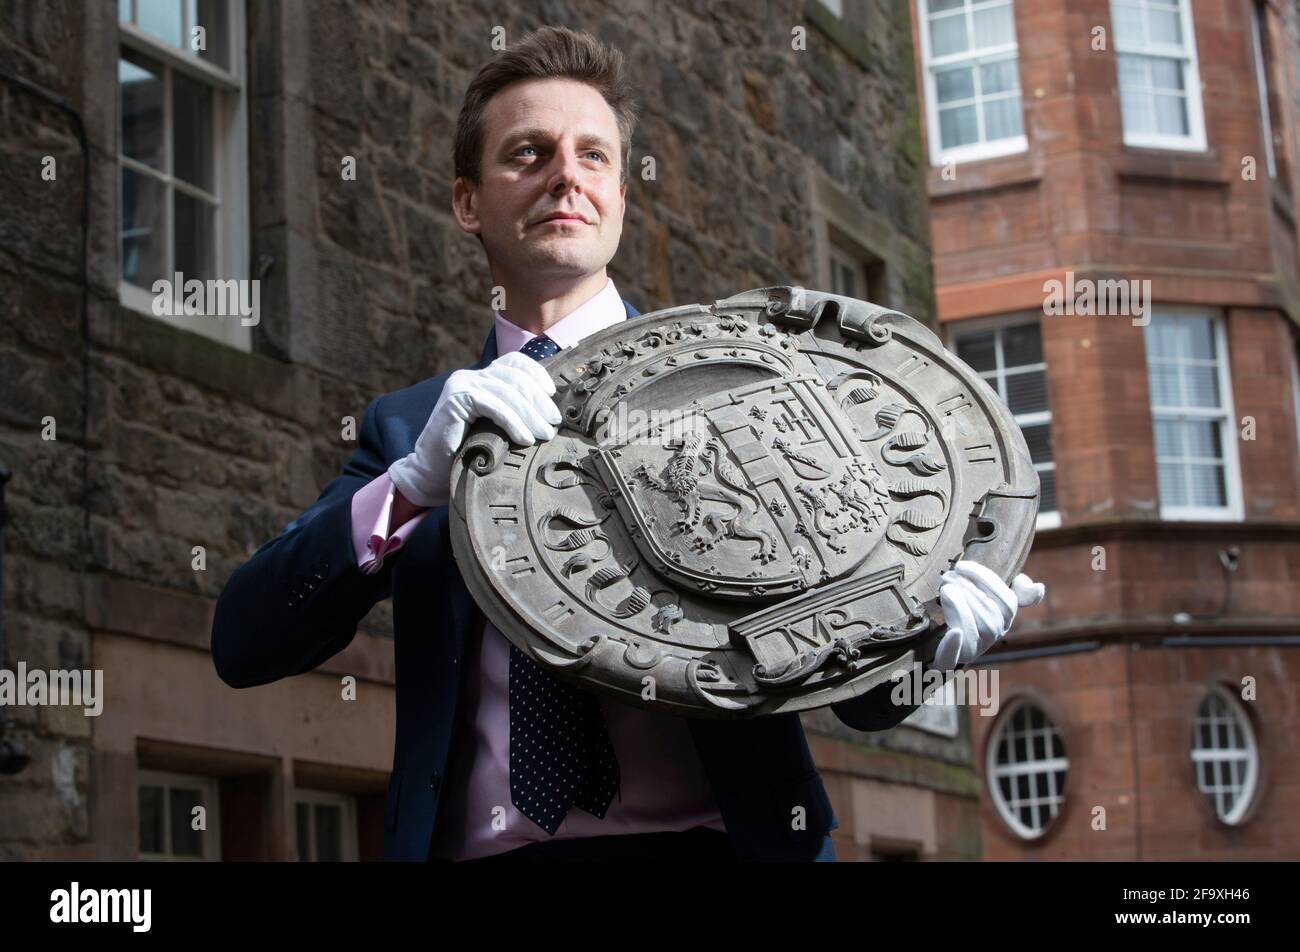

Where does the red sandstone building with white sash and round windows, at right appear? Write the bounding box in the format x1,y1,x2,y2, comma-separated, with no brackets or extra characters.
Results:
913,0,1300,860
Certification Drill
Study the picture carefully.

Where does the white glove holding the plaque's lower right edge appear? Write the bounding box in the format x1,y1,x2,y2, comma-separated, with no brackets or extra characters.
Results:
933,559,1047,671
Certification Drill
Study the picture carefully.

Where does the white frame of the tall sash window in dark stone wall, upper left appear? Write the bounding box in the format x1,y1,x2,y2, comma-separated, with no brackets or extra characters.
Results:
113,0,252,351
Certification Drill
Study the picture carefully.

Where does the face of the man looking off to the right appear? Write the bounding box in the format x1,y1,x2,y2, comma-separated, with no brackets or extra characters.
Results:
452,79,627,277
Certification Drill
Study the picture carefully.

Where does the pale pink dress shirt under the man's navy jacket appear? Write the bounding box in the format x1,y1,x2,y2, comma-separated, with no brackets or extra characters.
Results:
352,280,727,860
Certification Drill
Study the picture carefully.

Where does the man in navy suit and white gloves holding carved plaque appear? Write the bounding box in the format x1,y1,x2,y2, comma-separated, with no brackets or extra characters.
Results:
212,29,1032,861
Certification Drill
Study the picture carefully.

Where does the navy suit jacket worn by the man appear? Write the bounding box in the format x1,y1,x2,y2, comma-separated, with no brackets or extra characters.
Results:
212,300,915,861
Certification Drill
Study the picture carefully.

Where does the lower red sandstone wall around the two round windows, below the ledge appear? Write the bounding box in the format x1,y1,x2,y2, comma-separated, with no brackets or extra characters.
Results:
971,644,1300,860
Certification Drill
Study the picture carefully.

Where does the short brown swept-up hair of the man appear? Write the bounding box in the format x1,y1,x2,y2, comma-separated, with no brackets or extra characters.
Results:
452,26,637,183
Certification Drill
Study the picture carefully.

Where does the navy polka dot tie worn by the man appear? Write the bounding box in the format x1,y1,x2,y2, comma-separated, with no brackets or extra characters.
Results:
510,334,619,836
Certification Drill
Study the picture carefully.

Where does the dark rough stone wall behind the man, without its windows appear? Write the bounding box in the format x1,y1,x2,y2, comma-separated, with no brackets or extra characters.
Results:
0,0,933,858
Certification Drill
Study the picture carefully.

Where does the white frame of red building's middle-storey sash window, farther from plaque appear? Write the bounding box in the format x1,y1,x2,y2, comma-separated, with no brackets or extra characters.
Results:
1143,307,1245,523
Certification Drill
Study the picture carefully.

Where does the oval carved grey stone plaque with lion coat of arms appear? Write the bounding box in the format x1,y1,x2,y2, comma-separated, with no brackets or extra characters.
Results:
451,287,1039,718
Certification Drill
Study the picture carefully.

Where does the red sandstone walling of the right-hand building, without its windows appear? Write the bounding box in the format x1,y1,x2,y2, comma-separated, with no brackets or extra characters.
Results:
918,0,1300,860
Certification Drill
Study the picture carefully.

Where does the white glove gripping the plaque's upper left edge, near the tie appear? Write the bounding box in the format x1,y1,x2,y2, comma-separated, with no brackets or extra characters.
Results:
389,351,562,507
